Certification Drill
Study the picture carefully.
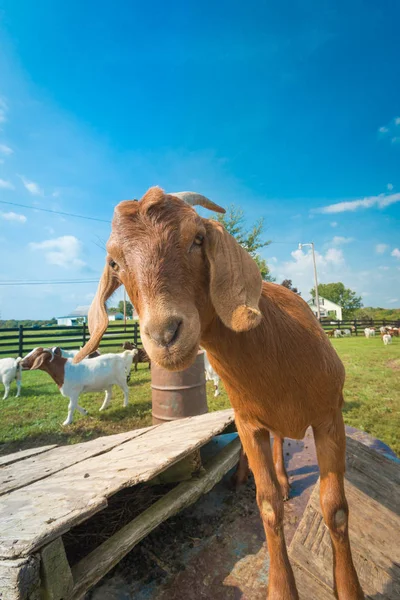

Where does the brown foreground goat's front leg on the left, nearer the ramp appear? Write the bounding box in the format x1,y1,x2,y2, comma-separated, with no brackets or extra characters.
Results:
236,415,299,600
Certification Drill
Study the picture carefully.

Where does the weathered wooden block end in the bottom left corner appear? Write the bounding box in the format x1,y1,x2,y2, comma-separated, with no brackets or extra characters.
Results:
0,556,40,600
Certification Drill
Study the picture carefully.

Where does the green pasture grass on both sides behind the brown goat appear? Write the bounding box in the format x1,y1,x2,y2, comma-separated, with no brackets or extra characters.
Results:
0,337,400,454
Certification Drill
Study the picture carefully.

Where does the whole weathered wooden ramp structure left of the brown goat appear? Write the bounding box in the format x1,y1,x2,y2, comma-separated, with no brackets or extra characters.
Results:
0,410,240,600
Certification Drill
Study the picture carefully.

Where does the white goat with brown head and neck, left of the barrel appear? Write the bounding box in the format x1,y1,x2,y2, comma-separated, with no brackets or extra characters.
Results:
21,348,137,425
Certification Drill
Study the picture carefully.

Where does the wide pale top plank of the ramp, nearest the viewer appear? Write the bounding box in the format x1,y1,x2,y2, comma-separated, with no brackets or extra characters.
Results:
0,409,234,558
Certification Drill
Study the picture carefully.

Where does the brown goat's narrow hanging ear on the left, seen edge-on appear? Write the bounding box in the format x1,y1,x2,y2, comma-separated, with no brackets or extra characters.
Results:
72,262,121,363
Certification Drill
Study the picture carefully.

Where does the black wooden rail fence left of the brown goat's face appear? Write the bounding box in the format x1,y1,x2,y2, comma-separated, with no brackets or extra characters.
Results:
0,321,142,356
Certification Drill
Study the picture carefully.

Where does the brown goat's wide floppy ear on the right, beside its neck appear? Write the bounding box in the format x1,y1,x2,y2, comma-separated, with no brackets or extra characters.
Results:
205,221,262,331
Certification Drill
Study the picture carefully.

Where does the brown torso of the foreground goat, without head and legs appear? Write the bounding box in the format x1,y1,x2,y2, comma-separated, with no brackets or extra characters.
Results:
202,283,345,437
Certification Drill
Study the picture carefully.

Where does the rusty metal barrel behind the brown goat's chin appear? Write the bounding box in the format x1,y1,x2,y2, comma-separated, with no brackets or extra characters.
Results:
151,350,208,425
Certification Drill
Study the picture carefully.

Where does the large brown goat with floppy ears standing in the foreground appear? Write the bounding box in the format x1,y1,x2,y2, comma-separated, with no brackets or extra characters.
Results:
74,188,364,600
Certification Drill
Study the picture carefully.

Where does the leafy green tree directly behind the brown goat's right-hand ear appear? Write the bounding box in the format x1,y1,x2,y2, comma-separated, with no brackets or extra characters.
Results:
217,204,275,281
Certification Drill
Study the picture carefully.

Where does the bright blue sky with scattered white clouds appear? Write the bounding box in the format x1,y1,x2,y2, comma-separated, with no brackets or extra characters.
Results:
0,0,400,319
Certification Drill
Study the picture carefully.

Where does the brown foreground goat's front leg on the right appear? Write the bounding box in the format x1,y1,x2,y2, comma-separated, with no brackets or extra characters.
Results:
313,410,364,600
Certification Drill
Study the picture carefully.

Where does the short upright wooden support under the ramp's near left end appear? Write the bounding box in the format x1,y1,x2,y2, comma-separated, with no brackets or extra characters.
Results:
40,538,74,600
